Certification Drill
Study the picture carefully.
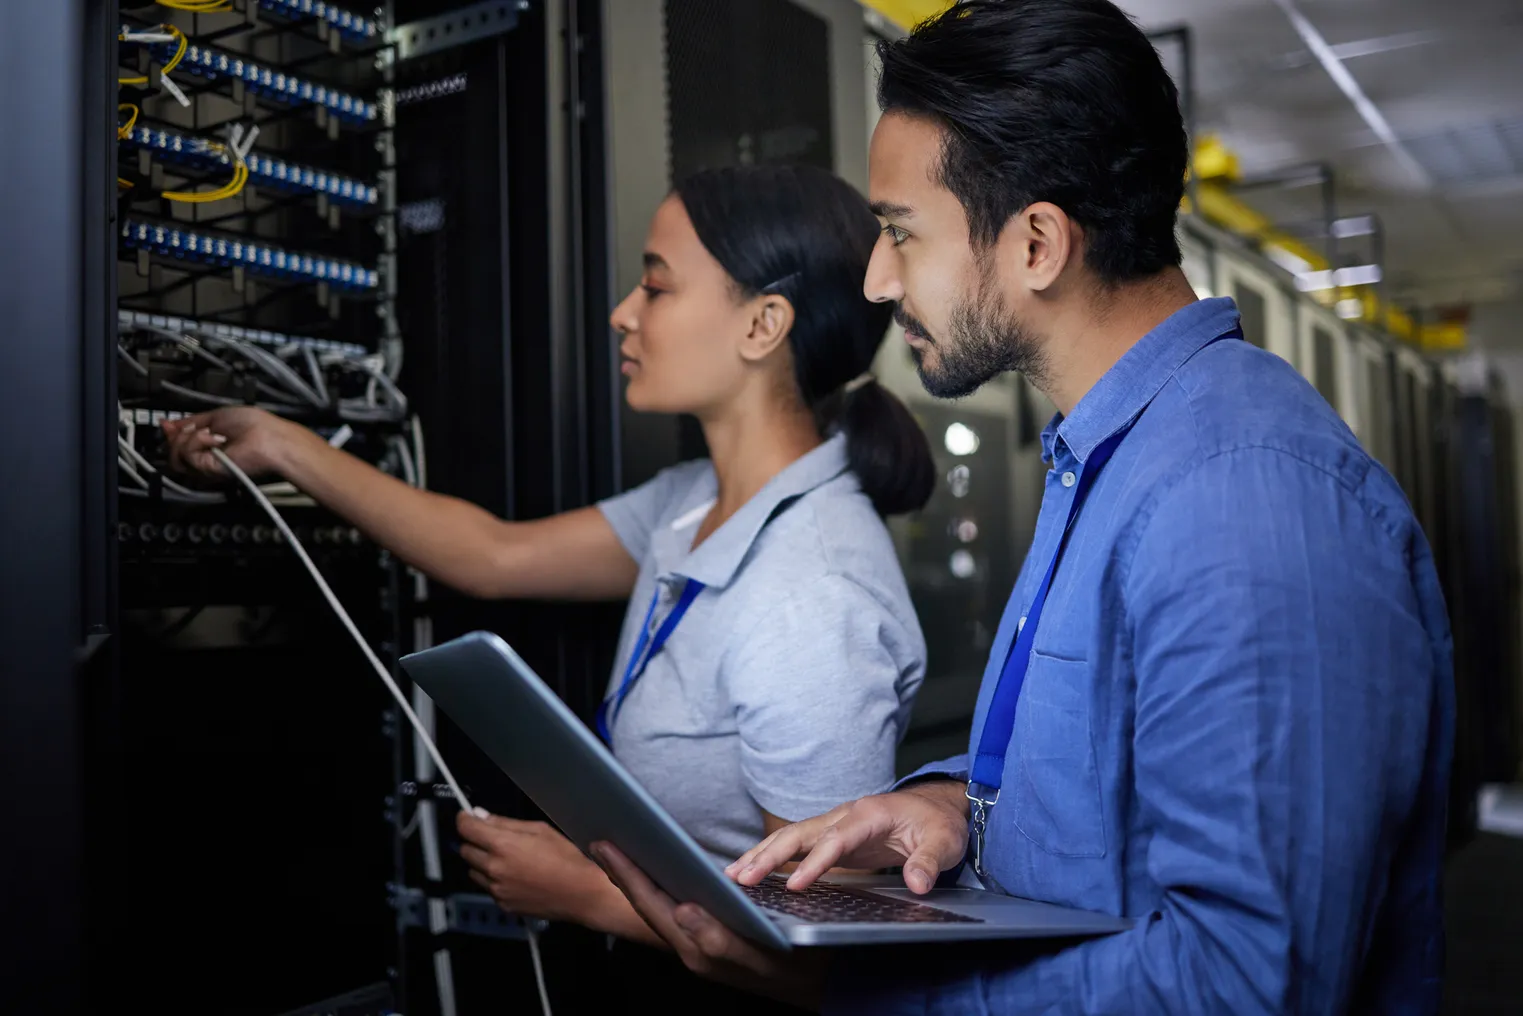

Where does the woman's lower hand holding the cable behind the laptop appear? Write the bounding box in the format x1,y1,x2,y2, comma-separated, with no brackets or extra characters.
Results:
455,812,618,928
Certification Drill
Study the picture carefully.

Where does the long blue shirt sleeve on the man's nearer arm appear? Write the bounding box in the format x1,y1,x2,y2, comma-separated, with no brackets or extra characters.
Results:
827,448,1447,1016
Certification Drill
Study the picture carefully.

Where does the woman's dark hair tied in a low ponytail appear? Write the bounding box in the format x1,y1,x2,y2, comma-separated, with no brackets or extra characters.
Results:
675,166,935,515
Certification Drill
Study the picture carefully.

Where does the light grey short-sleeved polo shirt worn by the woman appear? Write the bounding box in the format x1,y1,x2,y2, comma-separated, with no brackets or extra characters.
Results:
599,436,926,864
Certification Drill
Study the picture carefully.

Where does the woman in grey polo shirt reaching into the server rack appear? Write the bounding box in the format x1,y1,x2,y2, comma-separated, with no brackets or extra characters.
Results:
164,166,934,968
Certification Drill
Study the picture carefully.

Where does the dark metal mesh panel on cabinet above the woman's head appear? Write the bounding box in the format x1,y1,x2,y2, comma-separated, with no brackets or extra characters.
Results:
666,0,835,181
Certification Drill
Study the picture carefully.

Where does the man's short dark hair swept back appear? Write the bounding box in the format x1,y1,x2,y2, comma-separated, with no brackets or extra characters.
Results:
877,0,1189,283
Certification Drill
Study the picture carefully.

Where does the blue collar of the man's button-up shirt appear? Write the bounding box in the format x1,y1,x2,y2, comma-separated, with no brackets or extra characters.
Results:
1042,297,1238,463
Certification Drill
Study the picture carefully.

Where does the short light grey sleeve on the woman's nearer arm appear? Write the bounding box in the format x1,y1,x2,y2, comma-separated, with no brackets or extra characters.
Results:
720,576,924,821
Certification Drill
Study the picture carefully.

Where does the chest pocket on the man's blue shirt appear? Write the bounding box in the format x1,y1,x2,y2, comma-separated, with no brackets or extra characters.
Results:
1011,652,1106,858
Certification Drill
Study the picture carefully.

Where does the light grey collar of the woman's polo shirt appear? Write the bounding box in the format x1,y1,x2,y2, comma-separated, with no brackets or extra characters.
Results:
659,434,848,588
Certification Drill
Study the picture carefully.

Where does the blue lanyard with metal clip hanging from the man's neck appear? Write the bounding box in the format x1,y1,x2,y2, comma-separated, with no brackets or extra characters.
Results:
967,327,1243,877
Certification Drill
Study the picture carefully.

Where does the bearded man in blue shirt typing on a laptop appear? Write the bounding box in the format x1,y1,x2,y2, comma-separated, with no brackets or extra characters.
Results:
594,0,1453,1016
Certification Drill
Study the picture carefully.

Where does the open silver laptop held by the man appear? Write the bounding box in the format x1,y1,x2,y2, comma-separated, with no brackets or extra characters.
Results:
402,632,1132,949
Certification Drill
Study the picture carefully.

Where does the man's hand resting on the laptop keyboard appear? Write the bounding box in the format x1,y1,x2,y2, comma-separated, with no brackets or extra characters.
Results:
725,780,967,894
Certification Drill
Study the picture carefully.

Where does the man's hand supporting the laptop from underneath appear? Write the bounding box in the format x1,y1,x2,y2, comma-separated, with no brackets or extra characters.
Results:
589,842,825,1008
